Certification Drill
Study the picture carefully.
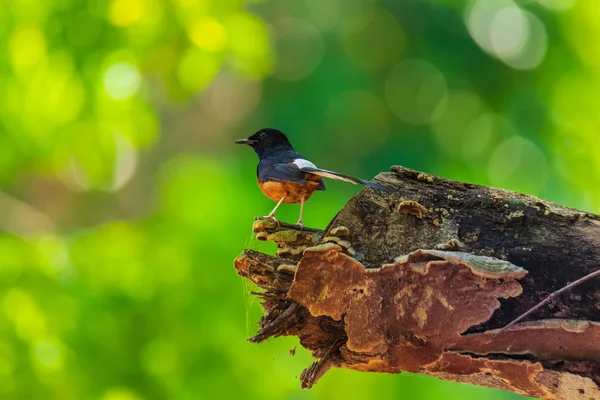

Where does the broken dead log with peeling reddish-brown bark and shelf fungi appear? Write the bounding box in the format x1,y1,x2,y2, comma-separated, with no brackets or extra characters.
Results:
235,167,600,400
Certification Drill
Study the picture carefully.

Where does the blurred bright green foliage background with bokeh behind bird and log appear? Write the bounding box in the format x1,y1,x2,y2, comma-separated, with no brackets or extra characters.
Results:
0,0,600,400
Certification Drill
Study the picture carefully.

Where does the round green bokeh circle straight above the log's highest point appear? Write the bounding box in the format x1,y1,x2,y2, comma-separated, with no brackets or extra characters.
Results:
385,59,447,125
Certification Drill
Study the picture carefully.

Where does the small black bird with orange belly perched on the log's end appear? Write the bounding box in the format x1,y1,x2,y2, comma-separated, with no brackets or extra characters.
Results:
235,128,385,226
